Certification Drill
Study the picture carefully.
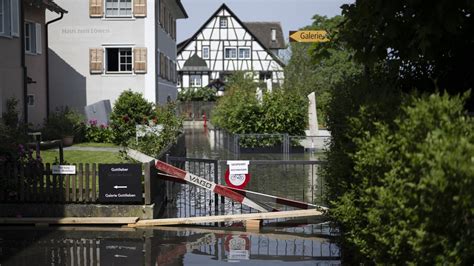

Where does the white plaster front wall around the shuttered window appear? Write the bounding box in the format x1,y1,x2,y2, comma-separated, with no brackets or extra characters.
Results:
47,0,146,111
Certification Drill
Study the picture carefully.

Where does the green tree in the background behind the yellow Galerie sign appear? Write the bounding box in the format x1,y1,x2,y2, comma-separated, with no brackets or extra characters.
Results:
284,15,361,126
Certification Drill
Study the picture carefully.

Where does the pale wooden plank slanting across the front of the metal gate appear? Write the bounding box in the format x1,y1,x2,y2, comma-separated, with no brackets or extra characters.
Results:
128,210,323,227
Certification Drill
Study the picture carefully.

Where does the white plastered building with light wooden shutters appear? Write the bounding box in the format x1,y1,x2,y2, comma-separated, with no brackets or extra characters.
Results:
48,0,187,111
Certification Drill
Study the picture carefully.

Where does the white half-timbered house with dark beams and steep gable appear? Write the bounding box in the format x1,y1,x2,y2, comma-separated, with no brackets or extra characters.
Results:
177,4,285,88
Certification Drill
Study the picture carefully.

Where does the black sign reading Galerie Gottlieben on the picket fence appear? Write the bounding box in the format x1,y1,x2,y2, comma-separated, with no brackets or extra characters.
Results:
99,164,142,203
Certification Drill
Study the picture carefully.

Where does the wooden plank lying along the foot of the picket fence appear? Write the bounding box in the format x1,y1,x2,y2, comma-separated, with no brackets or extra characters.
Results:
0,217,139,224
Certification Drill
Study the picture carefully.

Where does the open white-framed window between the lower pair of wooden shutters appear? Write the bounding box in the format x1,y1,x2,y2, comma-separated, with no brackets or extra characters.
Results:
105,48,133,73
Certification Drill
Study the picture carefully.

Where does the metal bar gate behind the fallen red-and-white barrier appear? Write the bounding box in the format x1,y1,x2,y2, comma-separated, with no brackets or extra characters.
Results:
161,156,324,222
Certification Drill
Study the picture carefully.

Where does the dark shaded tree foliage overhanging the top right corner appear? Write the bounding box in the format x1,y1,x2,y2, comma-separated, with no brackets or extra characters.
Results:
340,0,474,104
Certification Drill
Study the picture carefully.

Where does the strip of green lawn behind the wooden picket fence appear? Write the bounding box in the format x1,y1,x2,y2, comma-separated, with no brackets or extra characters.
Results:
41,149,127,164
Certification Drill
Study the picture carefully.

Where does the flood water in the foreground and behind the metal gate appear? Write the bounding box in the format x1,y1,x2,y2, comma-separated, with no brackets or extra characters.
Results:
0,125,341,266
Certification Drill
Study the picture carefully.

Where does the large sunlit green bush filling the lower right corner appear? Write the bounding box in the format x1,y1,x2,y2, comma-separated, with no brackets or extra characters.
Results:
332,90,474,265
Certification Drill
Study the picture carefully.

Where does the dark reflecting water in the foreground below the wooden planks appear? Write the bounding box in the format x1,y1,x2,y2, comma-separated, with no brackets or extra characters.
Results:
0,225,340,265
